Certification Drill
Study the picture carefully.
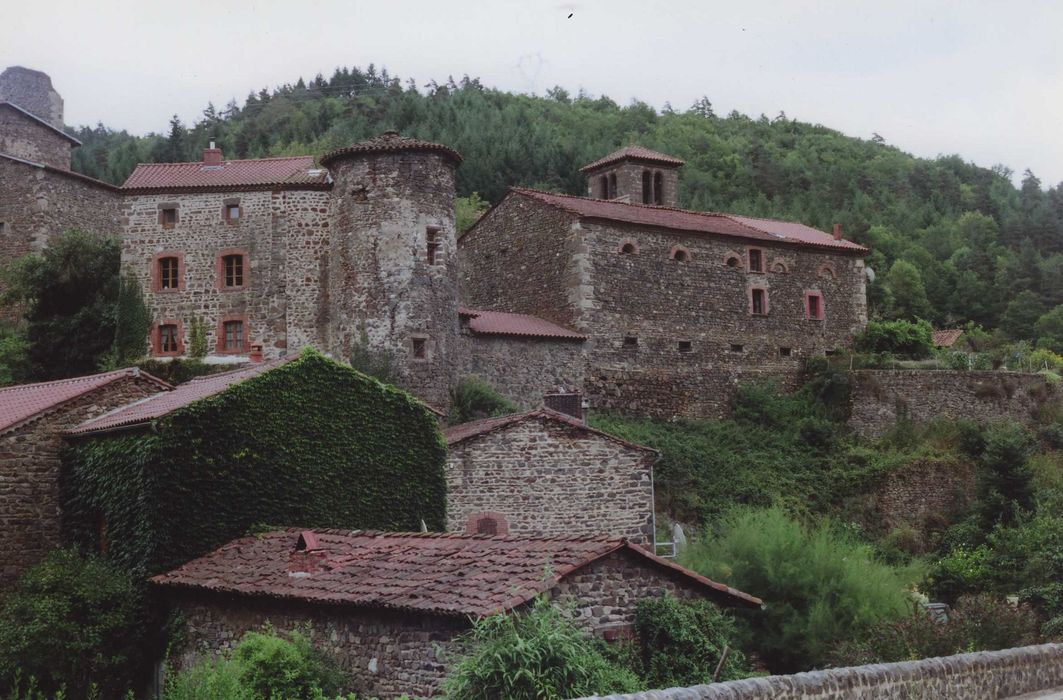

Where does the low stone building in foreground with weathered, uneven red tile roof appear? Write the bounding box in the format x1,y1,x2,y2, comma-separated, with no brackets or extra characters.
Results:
152,529,761,698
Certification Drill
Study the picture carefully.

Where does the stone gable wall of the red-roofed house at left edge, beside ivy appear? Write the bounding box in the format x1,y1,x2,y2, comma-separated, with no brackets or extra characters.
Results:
0,377,159,591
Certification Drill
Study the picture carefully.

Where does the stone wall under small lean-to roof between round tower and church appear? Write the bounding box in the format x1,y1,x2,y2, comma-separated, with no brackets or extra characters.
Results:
460,332,584,408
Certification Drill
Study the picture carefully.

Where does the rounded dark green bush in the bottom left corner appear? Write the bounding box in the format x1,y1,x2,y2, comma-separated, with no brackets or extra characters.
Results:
0,549,147,700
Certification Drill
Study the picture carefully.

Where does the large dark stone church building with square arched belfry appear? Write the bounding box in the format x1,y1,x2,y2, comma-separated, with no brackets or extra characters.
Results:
458,148,866,417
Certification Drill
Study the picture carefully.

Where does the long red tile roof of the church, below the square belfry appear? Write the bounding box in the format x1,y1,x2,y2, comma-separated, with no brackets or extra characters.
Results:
503,187,867,253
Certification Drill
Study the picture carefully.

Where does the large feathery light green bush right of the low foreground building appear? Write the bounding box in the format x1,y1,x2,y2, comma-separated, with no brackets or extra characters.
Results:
682,508,915,672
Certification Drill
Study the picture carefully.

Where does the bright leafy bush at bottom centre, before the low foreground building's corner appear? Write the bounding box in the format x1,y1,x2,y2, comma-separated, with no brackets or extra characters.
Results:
442,598,640,700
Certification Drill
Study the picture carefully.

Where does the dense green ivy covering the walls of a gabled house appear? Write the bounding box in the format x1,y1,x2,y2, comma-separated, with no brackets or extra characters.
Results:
63,351,446,574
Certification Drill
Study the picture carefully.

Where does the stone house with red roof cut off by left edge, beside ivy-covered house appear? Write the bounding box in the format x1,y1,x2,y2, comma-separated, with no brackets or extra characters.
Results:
0,369,171,591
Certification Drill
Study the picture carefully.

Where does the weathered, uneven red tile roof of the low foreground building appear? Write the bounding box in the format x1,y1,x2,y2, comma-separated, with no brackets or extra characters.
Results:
151,528,761,616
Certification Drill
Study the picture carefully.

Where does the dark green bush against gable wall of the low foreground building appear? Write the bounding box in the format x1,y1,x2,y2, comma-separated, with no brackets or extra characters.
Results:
635,596,749,688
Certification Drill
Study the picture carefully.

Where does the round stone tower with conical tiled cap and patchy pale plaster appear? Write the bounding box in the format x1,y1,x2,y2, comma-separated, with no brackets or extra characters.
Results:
321,132,461,409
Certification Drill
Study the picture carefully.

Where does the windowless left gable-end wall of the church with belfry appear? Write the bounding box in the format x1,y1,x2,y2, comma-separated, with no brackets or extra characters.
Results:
458,194,579,327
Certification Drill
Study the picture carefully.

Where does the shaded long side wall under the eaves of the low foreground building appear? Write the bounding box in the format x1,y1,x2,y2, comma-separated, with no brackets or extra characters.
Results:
165,593,468,698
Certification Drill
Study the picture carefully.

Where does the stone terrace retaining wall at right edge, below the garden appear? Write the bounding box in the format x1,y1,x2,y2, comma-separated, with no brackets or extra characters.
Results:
849,370,1061,437
